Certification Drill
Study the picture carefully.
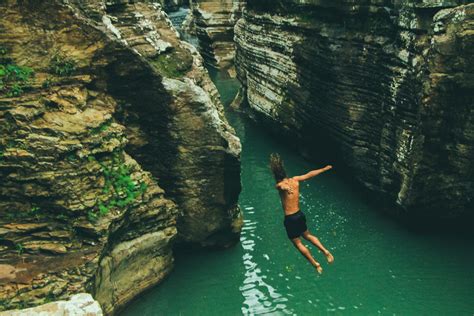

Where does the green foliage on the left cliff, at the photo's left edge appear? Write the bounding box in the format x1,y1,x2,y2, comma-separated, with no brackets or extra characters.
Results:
0,46,34,97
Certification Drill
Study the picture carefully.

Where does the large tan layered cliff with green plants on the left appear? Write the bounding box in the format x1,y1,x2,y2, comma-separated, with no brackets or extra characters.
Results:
0,1,240,314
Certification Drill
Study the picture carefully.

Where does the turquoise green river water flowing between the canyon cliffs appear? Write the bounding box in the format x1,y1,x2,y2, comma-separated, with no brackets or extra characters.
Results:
122,68,474,316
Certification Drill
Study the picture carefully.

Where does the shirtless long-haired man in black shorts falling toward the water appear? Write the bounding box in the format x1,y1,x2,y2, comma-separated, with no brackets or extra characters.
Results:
270,154,334,273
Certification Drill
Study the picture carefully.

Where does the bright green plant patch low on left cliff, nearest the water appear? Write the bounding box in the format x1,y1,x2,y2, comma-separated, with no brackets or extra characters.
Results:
87,152,147,222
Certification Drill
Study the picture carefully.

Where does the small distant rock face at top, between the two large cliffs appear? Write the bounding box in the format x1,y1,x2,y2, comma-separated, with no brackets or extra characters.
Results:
186,0,245,69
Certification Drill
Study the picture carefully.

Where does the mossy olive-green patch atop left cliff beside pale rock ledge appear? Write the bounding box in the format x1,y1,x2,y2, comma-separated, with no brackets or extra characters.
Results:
151,48,193,78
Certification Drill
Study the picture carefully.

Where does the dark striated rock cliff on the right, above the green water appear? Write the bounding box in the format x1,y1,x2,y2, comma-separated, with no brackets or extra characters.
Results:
235,0,474,217
